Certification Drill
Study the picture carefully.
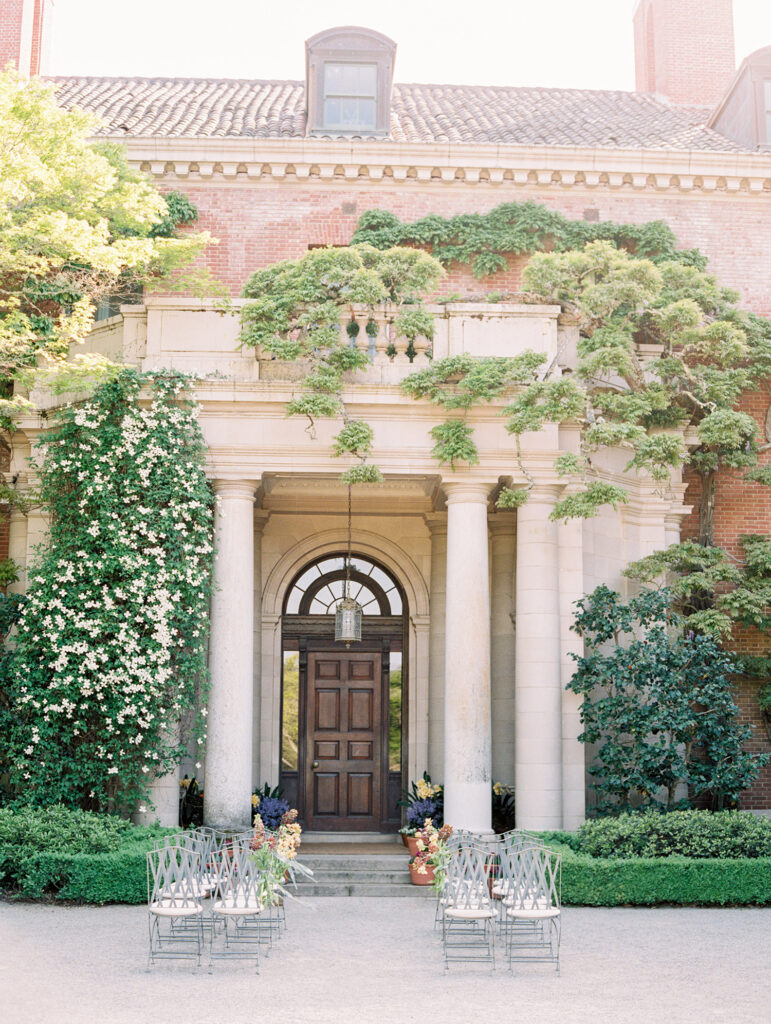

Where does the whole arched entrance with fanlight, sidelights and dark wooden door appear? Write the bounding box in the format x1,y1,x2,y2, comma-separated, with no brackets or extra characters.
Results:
280,553,408,831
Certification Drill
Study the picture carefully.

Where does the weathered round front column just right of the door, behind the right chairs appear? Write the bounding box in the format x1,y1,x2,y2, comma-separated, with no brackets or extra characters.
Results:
443,480,491,831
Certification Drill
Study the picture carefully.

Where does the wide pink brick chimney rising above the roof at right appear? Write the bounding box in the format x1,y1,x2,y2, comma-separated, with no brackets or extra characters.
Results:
634,0,736,106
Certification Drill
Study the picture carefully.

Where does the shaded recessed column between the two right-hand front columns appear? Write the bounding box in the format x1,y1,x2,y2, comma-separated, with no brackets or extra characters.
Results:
489,512,517,785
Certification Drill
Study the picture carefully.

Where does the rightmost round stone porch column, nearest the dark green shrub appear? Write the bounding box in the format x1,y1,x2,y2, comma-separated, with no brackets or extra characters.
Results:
515,486,562,829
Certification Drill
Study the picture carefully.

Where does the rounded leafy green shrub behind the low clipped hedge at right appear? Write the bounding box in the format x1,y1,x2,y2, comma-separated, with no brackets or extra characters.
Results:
577,811,771,860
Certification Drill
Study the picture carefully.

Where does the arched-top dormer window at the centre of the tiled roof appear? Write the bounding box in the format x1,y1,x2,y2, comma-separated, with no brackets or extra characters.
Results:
305,27,396,136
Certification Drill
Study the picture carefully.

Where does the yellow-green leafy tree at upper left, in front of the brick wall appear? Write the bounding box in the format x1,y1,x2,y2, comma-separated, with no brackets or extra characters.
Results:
0,70,212,409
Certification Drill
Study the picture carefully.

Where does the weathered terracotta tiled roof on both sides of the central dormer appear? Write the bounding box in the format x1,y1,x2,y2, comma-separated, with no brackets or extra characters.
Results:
46,78,741,153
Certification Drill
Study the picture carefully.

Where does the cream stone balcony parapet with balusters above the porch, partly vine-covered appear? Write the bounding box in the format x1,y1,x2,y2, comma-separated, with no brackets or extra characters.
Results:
78,298,574,386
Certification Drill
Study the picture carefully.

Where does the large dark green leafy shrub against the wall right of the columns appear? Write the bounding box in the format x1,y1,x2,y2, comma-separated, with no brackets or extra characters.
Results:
568,586,768,813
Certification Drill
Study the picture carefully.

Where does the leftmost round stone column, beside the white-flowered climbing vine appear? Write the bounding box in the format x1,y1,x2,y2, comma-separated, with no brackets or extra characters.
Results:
204,480,257,828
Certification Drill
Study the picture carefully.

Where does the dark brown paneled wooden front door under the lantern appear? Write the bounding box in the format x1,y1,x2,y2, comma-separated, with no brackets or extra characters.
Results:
305,650,385,831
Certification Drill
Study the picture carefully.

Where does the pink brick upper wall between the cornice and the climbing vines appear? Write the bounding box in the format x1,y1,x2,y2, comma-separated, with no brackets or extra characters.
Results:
170,180,771,315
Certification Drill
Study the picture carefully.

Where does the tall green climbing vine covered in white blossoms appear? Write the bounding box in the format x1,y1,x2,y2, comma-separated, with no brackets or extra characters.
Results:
11,371,213,807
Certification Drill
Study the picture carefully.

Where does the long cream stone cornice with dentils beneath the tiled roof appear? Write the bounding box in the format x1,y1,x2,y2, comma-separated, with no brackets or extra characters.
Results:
115,136,771,195
